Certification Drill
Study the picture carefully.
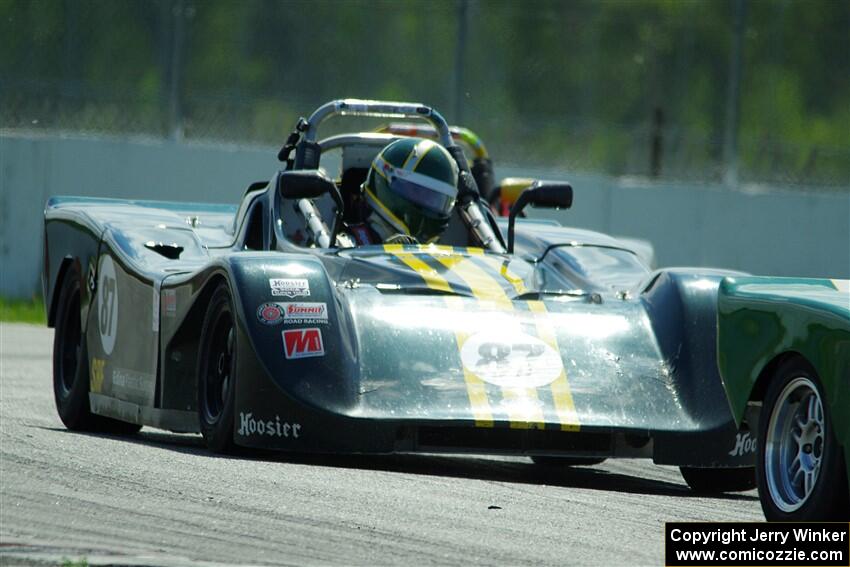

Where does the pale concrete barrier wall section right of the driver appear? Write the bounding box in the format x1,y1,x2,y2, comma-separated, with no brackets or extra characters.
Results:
510,164,850,279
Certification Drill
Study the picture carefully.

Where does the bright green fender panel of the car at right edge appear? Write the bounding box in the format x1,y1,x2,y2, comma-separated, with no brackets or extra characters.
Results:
717,277,850,482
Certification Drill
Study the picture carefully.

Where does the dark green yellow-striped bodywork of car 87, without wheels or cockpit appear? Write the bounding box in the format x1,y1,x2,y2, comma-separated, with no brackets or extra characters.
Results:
45,190,749,466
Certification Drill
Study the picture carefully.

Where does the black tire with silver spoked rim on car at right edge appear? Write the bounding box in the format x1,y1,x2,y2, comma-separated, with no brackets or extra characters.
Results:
756,358,850,522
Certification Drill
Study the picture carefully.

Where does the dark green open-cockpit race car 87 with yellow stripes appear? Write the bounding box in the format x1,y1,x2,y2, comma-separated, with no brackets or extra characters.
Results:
43,99,754,491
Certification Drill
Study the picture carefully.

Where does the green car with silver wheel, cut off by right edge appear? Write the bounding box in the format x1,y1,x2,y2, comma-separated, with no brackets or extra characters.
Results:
717,277,850,522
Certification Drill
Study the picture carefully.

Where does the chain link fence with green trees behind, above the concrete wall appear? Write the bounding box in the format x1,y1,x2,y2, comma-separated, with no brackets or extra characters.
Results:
0,0,850,191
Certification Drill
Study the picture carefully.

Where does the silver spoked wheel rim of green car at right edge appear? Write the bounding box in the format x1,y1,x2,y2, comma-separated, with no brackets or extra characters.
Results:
764,376,826,512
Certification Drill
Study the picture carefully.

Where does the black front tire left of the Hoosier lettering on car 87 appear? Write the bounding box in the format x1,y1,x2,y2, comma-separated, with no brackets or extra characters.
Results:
198,283,237,454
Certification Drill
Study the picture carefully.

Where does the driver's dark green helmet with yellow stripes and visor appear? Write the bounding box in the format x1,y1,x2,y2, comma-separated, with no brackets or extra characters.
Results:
363,138,458,242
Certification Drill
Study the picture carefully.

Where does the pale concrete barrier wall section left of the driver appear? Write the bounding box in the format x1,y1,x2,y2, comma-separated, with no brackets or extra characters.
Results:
0,134,278,297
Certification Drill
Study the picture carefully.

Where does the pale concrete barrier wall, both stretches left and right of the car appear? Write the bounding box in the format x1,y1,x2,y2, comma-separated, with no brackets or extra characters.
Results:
0,133,850,297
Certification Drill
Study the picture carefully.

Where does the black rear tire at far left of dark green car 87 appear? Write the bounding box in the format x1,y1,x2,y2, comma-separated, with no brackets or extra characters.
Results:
53,264,142,434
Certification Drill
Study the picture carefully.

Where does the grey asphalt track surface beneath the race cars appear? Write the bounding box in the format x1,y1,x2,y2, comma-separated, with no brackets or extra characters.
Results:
0,324,763,565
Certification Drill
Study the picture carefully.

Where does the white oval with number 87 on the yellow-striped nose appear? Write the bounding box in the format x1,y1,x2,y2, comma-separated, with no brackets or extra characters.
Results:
460,331,564,388
